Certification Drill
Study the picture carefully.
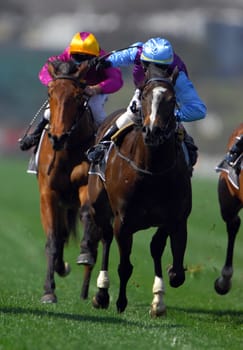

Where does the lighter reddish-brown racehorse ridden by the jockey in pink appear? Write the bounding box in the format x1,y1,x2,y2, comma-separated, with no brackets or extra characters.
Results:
37,61,95,303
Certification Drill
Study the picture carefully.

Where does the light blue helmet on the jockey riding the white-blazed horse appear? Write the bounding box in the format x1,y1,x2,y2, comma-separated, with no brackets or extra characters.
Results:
140,38,174,64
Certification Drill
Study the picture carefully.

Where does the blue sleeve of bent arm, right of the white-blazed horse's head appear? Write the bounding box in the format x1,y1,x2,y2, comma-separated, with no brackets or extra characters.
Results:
175,71,207,122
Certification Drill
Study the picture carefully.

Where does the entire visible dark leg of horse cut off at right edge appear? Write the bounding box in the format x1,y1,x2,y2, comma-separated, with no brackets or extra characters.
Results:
214,179,241,295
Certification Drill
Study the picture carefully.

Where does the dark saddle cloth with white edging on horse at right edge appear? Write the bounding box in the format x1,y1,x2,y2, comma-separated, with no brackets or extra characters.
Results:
215,154,243,190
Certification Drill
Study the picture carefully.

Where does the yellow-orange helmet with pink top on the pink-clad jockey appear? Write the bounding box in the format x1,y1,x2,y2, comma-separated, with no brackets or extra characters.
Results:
70,32,100,56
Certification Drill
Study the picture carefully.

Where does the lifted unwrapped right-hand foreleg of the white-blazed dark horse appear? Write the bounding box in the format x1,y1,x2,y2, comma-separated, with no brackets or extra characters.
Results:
168,219,187,288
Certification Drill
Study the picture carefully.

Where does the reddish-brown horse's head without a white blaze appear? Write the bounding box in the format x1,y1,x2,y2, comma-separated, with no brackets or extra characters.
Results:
48,61,89,151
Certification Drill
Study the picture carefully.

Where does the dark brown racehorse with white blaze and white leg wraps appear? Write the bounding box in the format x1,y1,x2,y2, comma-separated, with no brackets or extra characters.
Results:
83,65,192,317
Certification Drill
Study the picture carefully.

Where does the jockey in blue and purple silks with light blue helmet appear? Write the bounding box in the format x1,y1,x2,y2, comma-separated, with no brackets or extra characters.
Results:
87,38,206,166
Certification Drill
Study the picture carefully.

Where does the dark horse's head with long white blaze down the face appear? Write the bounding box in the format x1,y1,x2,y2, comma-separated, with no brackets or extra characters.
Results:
141,64,178,147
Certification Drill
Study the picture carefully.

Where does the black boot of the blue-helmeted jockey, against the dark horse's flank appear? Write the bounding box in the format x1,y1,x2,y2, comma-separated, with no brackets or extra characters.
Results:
86,124,119,164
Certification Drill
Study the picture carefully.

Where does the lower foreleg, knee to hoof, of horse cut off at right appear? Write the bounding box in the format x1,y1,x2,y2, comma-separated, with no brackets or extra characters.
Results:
214,216,241,295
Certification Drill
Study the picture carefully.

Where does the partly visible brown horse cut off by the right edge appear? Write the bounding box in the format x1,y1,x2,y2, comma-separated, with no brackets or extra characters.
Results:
214,123,243,295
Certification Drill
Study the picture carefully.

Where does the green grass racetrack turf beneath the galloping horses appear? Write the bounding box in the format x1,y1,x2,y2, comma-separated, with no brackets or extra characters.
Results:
0,159,243,350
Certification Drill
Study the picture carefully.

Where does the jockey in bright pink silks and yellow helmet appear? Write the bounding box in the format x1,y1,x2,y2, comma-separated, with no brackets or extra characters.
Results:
20,32,123,151
